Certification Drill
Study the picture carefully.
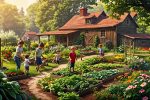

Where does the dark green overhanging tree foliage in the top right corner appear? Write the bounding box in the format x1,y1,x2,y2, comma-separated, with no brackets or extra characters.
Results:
101,0,150,31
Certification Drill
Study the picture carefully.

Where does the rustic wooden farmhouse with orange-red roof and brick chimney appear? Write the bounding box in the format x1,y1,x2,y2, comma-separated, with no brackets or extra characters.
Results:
38,8,138,46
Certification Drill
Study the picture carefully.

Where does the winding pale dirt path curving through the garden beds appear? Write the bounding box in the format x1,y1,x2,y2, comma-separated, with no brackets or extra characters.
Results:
19,53,113,100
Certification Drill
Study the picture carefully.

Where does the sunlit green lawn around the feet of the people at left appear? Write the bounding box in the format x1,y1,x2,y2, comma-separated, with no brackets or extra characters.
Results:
3,61,58,76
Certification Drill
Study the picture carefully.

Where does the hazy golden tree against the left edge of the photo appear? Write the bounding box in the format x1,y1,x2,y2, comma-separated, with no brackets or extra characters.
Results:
0,3,25,36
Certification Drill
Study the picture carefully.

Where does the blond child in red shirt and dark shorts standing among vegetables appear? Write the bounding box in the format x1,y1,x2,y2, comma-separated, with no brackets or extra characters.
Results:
69,47,77,72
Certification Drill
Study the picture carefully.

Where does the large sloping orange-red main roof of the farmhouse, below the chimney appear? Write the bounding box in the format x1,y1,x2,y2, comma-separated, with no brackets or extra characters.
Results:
59,12,137,30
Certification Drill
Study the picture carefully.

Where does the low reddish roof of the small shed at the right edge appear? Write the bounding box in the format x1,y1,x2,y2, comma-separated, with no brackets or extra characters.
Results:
124,33,150,39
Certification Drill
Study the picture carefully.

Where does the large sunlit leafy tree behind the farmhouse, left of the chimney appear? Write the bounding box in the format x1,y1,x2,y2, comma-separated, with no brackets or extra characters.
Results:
29,0,96,32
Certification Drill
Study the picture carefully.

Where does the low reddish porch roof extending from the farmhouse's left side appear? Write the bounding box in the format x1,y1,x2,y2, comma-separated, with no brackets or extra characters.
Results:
37,30,77,36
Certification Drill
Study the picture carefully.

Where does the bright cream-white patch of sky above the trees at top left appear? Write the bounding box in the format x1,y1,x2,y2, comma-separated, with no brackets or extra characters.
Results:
5,0,36,10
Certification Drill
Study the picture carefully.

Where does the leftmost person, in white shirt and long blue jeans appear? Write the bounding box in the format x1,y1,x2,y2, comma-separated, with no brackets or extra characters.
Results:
14,41,24,70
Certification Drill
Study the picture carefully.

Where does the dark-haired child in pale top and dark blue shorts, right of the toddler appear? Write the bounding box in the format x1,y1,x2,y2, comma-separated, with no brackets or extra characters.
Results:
35,43,44,71
